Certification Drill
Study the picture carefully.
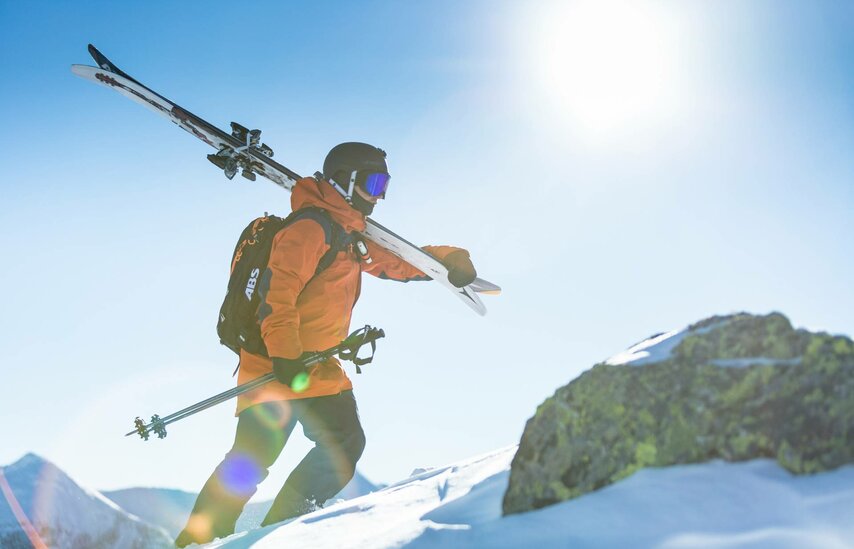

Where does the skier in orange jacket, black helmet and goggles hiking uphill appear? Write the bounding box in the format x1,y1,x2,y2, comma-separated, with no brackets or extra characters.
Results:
175,142,476,547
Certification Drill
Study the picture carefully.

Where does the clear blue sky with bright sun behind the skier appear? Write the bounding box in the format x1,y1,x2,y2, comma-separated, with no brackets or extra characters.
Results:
0,1,854,496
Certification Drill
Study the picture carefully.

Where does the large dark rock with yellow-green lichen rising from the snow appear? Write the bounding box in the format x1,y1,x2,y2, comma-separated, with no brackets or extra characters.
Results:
504,313,854,514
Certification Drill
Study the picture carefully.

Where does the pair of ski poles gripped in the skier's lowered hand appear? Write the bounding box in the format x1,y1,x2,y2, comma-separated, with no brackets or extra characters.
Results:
125,325,385,440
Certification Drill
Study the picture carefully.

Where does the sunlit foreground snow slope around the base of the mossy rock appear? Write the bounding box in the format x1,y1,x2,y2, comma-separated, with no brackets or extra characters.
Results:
208,446,854,549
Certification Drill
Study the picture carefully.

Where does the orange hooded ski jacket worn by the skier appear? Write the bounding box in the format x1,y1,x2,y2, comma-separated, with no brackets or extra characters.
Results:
237,177,459,414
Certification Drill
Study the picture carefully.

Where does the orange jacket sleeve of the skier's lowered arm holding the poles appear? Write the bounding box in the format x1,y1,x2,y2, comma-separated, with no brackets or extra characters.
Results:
258,219,329,358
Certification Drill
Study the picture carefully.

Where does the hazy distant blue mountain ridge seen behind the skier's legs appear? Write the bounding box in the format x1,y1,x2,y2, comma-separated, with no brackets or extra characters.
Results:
103,471,379,538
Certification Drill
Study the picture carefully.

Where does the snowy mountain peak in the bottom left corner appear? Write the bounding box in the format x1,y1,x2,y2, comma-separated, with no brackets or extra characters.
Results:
0,454,172,549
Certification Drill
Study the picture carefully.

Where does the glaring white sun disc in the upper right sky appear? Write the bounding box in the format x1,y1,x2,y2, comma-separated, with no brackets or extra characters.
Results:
529,0,679,137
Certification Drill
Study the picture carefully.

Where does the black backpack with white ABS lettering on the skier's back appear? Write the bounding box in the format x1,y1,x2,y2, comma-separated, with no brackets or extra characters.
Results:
216,207,350,357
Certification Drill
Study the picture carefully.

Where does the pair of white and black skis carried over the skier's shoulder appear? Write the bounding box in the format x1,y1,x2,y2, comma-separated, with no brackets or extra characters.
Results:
71,44,501,315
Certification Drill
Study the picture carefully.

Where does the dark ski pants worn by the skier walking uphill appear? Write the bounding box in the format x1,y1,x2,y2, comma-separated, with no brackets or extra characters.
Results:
179,391,365,541
